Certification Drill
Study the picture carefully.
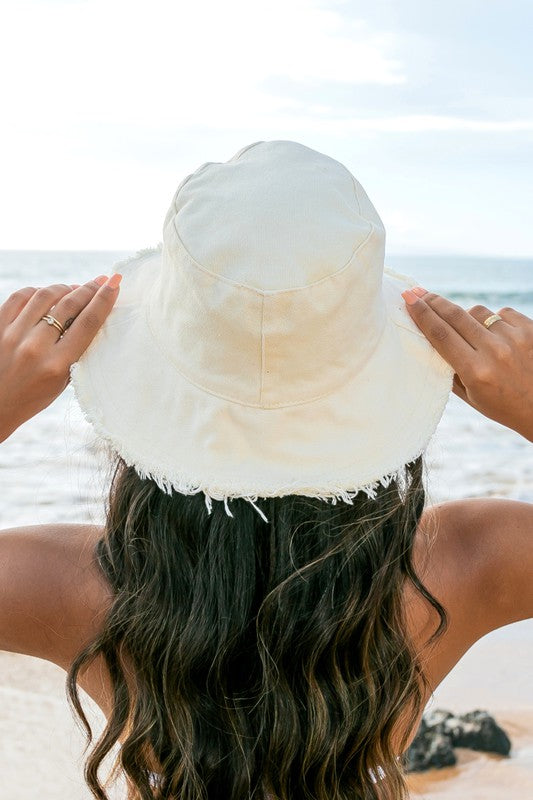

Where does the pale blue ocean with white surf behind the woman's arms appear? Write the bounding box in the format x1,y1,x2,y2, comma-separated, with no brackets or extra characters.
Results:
0,251,533,528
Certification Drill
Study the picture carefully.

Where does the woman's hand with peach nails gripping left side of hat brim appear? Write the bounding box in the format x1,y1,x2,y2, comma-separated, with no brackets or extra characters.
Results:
0,274,121,442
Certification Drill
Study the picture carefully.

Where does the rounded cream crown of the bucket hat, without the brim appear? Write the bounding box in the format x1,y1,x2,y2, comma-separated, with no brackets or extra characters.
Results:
147,140,386,408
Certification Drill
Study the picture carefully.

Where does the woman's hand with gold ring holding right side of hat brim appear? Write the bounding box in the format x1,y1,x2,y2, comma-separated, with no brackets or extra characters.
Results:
402,287,533,442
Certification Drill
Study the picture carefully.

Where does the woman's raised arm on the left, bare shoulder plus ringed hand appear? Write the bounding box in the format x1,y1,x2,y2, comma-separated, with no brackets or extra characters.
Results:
0,275,121,665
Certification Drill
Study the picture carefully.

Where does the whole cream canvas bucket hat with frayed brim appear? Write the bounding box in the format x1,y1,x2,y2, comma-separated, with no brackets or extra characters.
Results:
71,141,453,517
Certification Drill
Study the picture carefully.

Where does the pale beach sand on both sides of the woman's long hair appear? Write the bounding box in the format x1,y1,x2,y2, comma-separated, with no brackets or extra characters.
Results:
0,620,533,800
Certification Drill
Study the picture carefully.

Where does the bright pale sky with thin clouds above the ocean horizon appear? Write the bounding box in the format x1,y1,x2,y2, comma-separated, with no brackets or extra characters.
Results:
0,0,533,258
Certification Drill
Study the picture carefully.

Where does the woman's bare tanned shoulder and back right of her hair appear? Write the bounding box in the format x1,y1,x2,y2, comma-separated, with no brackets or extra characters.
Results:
406,498,533,688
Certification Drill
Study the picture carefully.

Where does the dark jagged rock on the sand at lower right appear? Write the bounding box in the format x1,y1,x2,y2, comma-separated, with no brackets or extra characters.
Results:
405,709,511,772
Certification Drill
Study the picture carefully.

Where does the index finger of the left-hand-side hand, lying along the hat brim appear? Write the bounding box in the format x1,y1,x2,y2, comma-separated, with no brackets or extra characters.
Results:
56,273,122,364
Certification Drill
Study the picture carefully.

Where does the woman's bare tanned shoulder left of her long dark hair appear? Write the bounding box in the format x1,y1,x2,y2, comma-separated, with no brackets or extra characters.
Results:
0,524,111,666
